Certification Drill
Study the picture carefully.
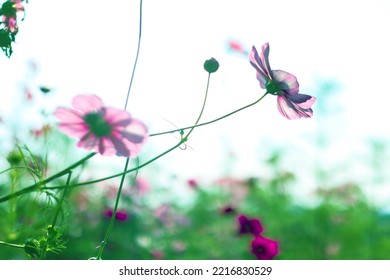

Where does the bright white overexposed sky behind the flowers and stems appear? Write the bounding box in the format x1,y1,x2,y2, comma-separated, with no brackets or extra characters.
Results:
0,0,390,208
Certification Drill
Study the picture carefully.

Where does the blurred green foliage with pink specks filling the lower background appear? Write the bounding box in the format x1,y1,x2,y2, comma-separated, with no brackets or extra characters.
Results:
0,151,390,260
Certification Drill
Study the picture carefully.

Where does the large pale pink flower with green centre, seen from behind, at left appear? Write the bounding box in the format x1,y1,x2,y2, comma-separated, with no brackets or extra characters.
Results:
55,95,148,157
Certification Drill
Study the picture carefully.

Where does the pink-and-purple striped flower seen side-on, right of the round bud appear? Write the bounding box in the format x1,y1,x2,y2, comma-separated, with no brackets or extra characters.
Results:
249,43,316,120
